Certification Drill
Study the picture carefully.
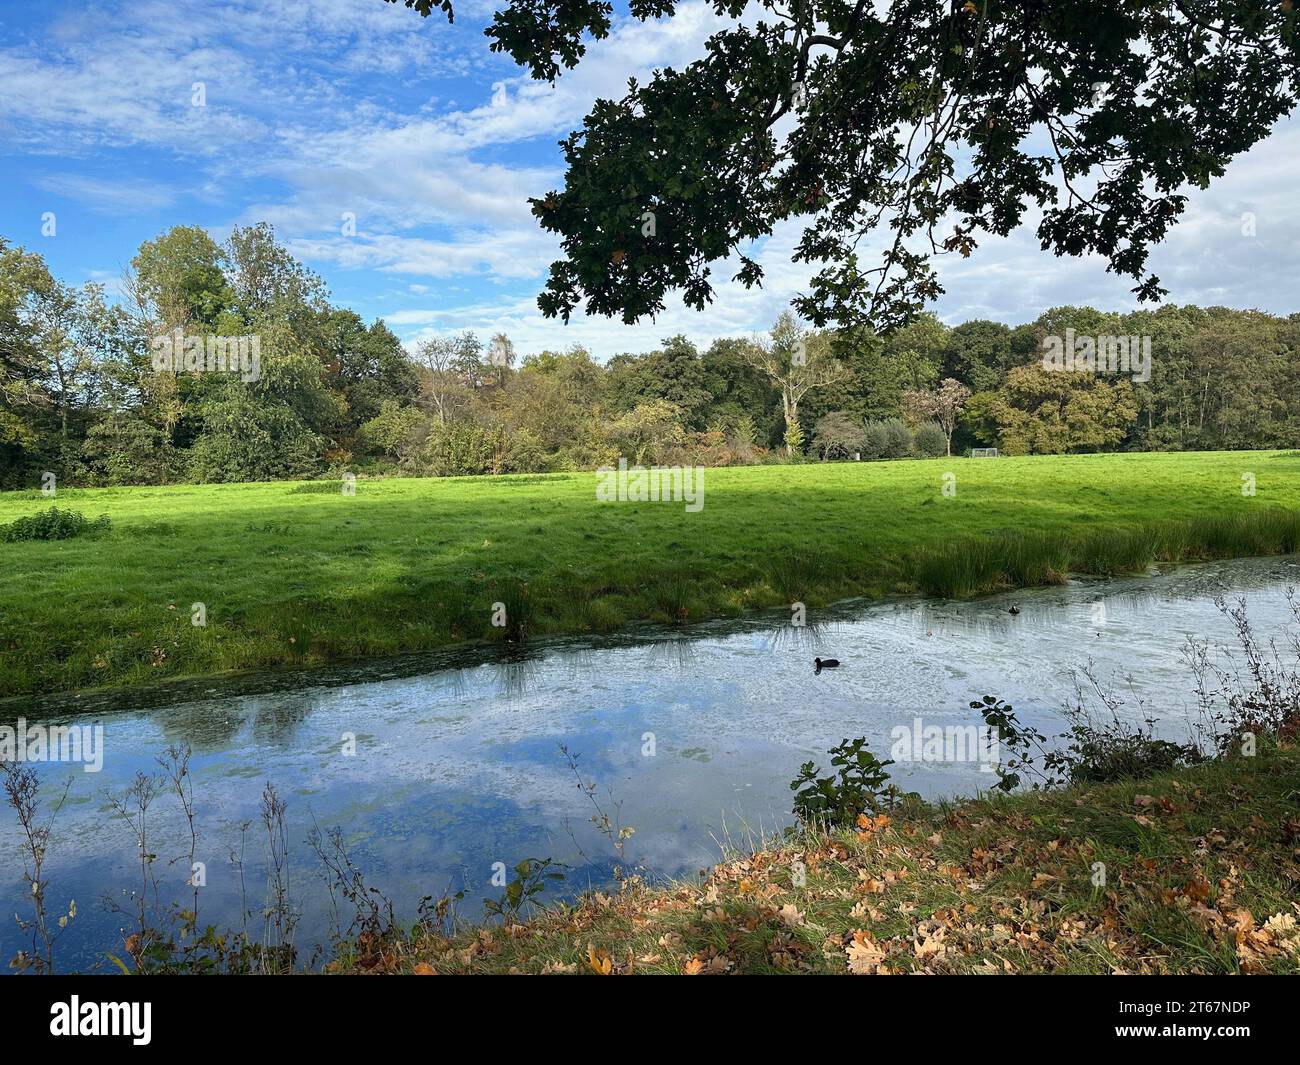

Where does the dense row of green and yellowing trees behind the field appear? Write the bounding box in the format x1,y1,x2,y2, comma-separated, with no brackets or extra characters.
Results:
0,225,1300,489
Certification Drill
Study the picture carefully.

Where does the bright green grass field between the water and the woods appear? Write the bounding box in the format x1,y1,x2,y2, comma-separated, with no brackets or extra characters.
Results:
0,453,1300,696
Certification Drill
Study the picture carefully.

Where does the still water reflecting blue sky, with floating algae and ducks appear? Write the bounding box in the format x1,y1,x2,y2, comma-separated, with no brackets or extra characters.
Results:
0,557,1300,971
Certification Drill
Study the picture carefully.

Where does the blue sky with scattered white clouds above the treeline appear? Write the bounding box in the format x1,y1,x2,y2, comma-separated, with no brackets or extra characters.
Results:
0,0,1300,360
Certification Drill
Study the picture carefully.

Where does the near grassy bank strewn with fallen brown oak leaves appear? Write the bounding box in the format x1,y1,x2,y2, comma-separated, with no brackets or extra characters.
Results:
332,748,1300,974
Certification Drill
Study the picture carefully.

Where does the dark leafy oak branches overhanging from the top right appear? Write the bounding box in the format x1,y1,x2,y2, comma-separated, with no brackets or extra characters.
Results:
387,0,1300,332
